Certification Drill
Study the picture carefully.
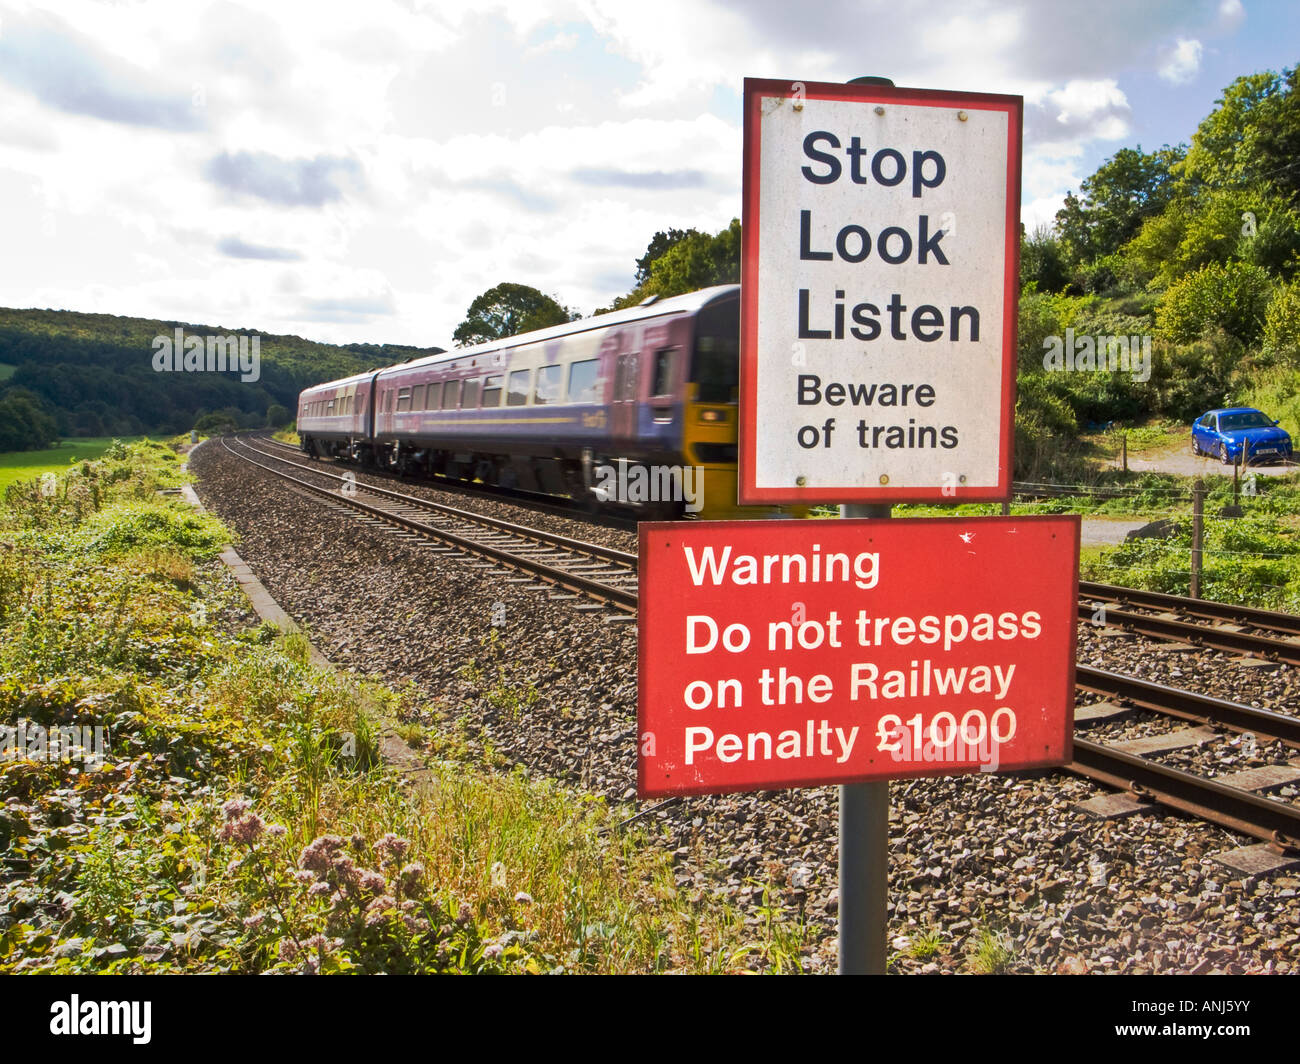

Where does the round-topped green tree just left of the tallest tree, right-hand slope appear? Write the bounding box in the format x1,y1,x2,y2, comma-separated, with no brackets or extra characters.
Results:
1056,144,1186,265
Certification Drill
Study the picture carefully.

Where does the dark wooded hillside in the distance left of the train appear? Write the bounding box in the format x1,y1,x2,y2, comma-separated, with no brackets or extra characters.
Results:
0,308,441,449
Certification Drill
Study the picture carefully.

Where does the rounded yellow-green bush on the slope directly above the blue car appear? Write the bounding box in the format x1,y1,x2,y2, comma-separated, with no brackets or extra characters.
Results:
1156,261,1271,343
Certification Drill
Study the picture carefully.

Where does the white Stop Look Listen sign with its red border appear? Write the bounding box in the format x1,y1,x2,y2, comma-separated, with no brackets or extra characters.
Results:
740,78,1023,503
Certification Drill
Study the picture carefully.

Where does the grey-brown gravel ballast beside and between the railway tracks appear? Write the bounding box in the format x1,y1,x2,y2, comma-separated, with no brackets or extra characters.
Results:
190,442,1300,973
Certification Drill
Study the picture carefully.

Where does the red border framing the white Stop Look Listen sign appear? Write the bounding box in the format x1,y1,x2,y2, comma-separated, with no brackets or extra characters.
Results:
736,78,1024,506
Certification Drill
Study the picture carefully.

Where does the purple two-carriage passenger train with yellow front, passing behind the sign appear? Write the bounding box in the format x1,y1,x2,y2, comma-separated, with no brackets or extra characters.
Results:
298,285,794,519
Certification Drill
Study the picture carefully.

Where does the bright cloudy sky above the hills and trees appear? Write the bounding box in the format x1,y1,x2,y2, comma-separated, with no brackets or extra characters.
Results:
0,0,1300,346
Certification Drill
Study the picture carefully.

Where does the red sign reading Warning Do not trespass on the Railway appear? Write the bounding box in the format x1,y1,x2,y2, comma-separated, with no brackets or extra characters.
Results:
637,515,1079,797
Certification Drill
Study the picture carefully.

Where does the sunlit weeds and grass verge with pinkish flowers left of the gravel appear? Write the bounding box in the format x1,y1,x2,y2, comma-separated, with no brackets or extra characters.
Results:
0,441,801,973
